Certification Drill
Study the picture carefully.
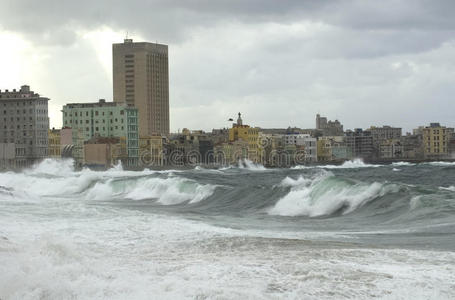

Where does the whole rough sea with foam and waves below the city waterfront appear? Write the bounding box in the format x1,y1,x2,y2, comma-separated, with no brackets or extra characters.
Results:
0,160,455,300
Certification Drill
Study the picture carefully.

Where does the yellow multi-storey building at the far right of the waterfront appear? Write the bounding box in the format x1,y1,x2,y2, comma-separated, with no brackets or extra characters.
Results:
422,123,454,158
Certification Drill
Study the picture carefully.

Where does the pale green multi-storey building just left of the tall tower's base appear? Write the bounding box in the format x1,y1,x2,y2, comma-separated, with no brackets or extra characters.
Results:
62,99,139,167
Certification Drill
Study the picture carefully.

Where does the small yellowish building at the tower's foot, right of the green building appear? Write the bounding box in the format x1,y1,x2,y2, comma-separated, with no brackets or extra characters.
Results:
139,135,164,166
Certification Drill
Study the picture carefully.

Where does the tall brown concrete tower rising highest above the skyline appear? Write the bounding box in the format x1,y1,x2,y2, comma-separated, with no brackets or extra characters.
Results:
112,39,169,136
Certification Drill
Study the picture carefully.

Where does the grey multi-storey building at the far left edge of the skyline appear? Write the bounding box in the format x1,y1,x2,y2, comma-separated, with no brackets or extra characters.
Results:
0,85,49,168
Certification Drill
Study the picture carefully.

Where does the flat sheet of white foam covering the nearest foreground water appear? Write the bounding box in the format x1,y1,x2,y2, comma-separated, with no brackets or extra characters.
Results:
0,212,455,300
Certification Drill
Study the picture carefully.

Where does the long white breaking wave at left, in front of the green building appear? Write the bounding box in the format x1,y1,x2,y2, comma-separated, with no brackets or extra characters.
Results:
0,159,216,205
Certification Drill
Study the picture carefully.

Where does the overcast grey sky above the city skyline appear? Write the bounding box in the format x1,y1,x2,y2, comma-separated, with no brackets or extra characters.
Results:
0,0,455,131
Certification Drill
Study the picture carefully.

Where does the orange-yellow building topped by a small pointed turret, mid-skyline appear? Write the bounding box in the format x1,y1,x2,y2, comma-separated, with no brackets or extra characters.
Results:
229,113,264,163
